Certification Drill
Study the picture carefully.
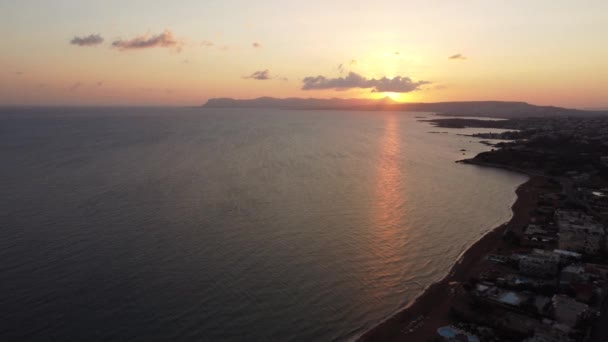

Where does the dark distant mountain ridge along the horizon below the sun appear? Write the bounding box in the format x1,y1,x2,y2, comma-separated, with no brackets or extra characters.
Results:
203,97,608,118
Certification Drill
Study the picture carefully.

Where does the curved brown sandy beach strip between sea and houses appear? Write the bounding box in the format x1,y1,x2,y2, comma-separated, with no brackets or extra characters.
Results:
357,170,547,341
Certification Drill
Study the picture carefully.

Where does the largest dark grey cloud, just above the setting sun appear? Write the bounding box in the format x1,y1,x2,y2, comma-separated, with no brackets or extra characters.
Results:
302,72,430,93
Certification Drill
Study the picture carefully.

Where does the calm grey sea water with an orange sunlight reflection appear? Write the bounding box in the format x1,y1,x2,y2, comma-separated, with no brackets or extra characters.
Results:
0,108,526,341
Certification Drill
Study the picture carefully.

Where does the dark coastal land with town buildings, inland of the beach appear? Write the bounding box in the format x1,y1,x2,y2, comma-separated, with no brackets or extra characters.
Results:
430,117,608,342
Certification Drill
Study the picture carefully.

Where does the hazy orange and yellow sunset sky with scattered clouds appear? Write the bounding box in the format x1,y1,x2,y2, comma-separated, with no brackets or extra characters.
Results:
0,0,608,108
